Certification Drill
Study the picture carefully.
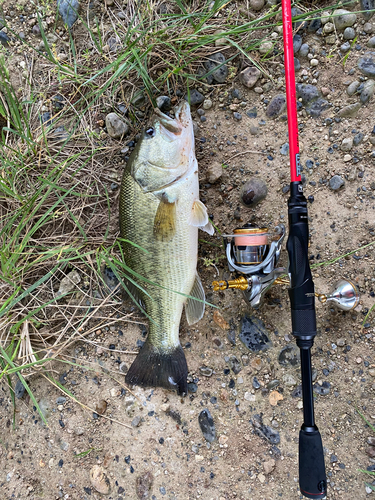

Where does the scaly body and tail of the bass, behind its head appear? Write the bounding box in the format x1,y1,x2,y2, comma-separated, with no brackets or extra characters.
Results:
120,168,199,393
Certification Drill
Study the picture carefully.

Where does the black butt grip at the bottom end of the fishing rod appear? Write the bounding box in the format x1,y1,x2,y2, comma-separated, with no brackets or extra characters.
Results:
299,425,327,498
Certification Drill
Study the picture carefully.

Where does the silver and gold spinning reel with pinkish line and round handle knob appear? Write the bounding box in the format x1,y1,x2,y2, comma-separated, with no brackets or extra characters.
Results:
212,224,359,311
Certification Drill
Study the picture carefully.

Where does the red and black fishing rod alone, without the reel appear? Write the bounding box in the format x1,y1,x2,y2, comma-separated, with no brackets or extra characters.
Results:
282,0,327,498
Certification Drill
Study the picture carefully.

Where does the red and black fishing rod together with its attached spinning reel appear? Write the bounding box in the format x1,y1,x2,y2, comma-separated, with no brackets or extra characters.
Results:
212,0,359,499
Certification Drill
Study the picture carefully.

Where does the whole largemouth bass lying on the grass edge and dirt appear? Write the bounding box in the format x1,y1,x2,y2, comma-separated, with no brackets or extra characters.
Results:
120,102,213,394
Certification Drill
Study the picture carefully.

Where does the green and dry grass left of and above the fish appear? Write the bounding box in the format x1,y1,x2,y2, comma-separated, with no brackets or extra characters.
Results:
0,0,374,424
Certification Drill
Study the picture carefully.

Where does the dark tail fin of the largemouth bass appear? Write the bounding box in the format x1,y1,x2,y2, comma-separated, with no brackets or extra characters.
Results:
125,340,188,394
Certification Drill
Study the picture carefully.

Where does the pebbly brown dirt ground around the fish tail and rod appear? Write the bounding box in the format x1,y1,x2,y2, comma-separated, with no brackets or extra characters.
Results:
0,0,375,500
